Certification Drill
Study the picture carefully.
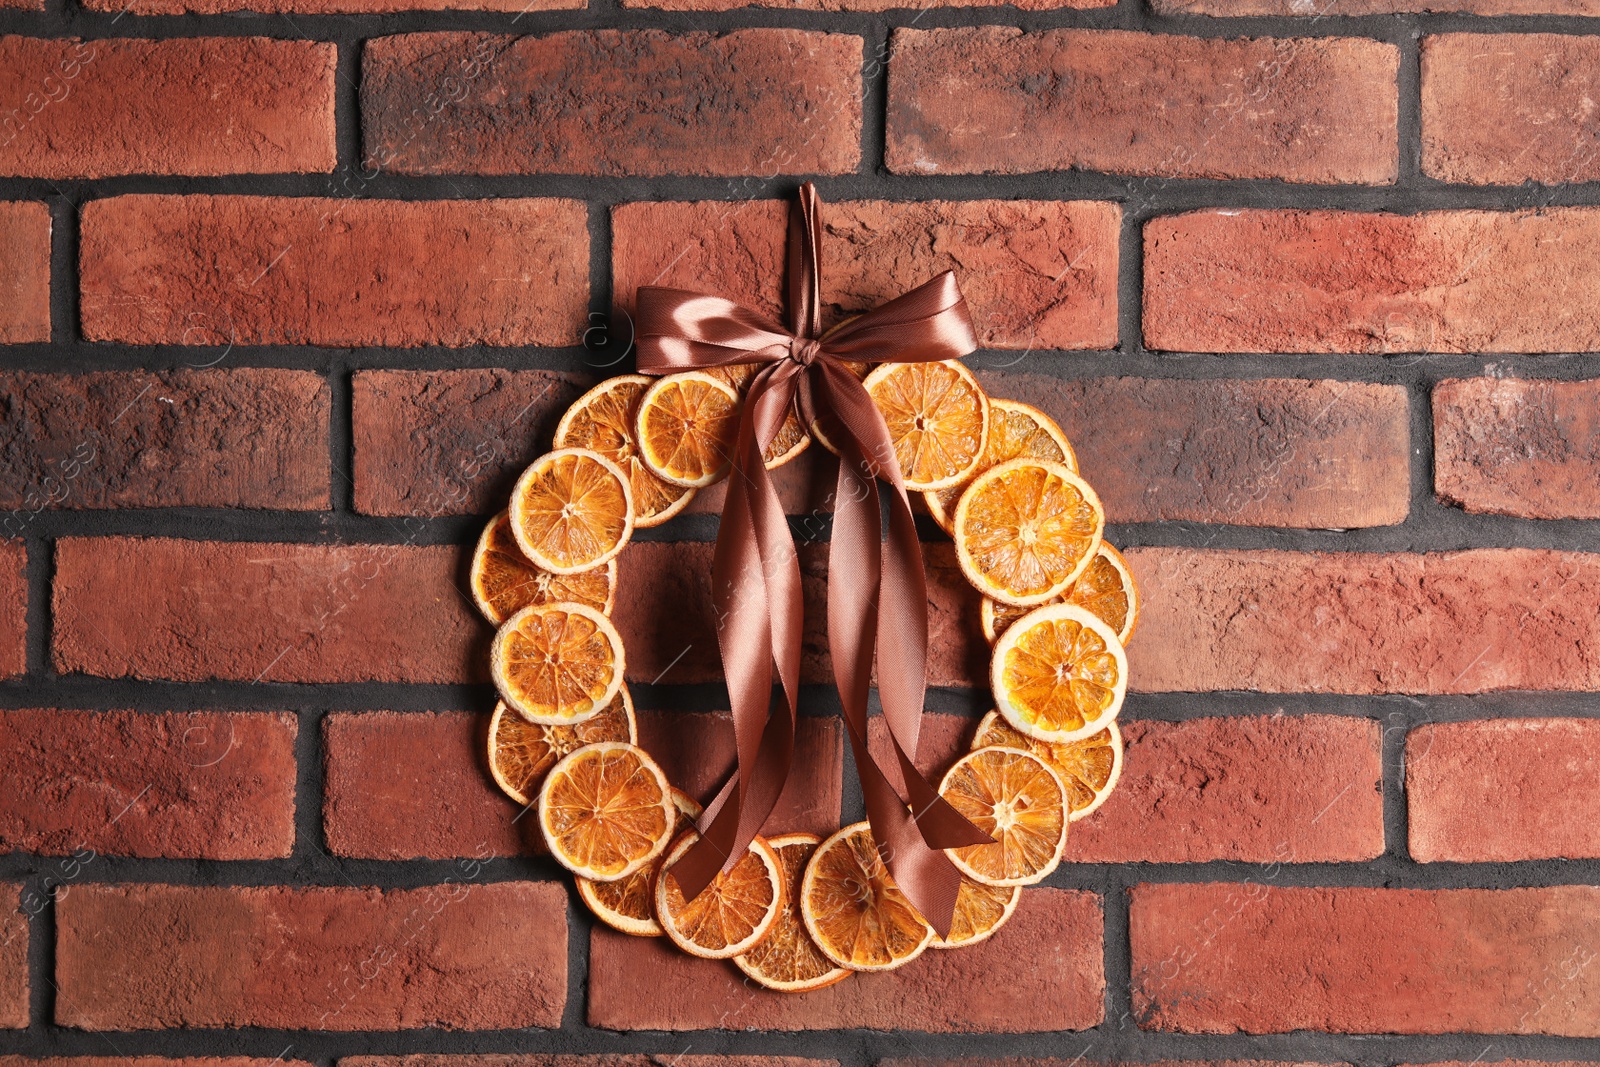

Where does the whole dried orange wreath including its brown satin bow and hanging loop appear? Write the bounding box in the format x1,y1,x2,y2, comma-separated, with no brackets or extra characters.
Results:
472,182,1138,992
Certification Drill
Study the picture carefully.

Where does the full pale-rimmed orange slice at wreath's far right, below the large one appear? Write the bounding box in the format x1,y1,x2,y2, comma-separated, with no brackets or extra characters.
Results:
989,605,1128,741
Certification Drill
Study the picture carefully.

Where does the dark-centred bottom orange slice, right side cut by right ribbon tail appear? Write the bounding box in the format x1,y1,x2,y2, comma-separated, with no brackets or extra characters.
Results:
800,822,933,971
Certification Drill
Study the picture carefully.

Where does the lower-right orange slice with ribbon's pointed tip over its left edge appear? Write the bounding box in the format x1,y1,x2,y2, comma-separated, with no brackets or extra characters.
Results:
939,749,1069,886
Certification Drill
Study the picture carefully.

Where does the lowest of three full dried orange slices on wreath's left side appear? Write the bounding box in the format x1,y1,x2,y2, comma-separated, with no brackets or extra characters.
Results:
539,741,678,881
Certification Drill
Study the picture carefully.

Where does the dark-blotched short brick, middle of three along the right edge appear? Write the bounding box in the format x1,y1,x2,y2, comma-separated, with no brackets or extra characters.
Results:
1434,378,1600,518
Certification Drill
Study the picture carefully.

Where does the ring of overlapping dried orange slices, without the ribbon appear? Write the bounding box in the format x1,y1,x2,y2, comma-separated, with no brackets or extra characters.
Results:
470,362,1139,992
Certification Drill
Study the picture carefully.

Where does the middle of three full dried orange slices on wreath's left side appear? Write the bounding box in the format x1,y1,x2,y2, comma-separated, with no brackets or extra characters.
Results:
490,603,627,725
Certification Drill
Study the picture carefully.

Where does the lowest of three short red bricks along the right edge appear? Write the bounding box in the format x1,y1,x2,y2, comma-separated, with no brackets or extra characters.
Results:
1405,718,1600,864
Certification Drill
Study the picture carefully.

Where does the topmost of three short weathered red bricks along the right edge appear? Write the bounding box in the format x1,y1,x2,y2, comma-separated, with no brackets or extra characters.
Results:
1422,34,1600,186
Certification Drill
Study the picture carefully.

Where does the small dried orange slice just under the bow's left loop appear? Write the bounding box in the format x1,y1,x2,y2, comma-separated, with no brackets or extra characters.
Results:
634,371,739,488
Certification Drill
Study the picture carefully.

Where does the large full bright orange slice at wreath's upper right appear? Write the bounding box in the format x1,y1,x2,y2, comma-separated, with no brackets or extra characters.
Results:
950,459,1106,605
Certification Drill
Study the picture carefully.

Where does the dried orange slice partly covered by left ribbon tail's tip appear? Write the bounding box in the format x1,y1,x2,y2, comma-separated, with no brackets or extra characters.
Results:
656,830,784,960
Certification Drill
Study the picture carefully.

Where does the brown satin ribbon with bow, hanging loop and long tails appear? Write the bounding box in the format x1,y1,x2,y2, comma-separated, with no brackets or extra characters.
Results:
637,182,990,936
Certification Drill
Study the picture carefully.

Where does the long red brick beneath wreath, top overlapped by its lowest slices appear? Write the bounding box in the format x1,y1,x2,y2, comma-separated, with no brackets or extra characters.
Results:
589,888,1106,1033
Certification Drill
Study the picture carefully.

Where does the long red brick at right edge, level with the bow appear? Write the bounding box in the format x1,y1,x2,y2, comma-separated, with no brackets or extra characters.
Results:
1144,208,1600,352
